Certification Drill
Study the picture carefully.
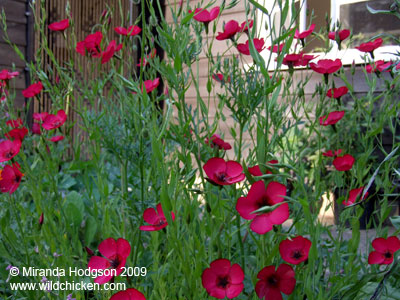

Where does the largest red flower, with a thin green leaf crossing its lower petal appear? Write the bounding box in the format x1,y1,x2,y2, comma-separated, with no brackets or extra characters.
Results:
236,180,289,234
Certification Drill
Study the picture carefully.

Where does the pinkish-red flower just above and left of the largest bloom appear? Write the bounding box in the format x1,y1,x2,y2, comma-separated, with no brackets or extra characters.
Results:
203,157,245,185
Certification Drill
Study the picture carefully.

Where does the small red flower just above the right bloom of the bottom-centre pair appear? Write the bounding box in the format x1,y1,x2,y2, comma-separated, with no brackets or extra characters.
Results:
279,236,311,265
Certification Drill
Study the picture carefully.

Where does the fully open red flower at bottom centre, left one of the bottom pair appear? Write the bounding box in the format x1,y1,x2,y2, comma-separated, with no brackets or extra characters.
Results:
201,258,244,299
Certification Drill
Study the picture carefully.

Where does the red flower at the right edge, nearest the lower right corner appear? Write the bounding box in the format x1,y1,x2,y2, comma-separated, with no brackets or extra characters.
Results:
368,236,400,265
